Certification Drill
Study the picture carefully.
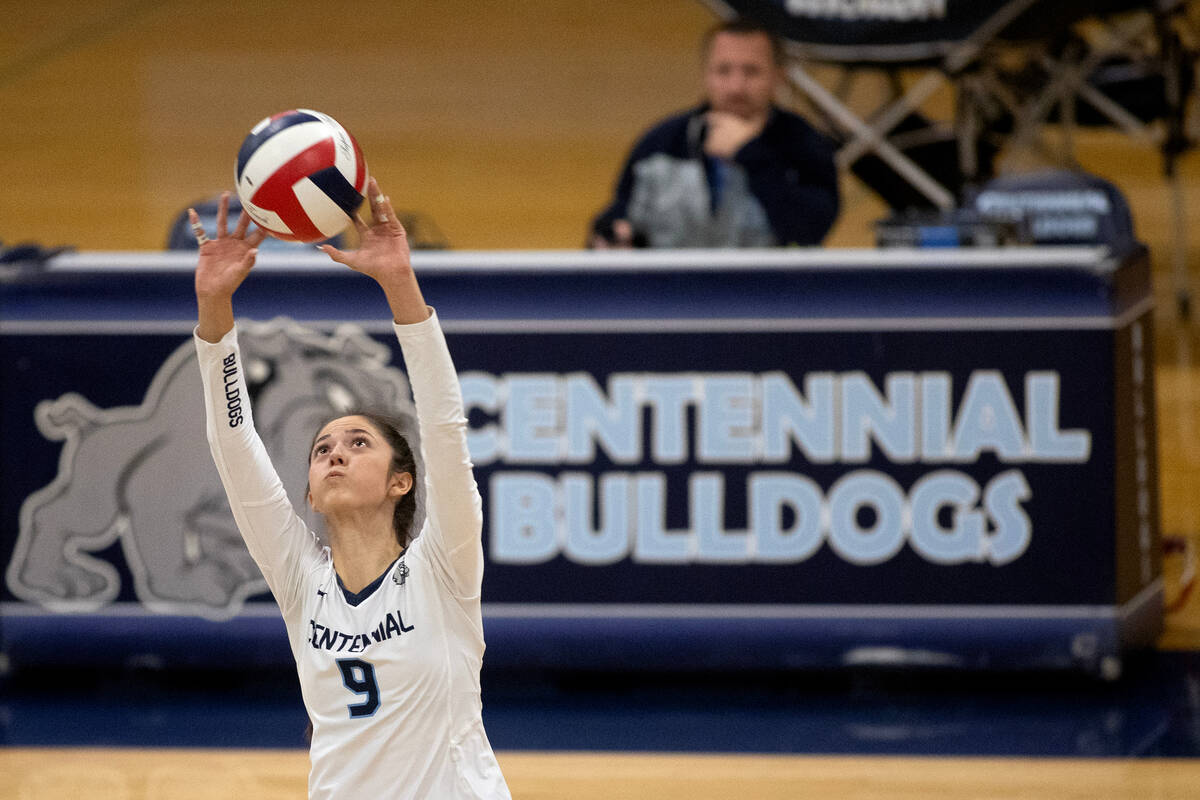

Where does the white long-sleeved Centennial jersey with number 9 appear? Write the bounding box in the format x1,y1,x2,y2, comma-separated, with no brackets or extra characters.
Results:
194,313,510,800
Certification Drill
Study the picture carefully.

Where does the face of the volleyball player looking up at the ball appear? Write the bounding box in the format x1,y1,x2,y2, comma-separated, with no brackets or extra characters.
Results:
308,416,413,513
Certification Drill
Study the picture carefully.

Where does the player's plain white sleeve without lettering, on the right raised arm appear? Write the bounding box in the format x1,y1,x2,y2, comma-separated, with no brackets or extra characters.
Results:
394,308,484,600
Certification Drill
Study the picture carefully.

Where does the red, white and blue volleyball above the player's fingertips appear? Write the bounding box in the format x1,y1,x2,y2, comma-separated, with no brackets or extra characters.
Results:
236,108,367,242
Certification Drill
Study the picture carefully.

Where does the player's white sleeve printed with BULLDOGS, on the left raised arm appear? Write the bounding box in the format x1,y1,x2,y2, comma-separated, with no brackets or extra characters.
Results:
193,329,320,618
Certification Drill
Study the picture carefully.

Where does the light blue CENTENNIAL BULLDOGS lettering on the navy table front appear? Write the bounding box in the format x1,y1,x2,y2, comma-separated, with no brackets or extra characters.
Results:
472,371,1091,565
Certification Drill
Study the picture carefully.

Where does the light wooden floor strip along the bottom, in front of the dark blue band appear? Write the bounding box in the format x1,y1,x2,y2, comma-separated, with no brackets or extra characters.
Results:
0,750,1200,800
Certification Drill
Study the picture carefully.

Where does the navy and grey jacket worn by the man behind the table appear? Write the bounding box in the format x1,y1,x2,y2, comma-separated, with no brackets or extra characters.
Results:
592,106,838,247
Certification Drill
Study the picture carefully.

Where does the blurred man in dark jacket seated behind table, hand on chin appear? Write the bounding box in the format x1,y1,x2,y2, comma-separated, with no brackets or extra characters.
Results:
588,20,838,248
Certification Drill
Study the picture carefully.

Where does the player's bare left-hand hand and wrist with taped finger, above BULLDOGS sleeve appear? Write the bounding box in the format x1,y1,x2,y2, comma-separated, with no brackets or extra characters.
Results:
187,192,266,342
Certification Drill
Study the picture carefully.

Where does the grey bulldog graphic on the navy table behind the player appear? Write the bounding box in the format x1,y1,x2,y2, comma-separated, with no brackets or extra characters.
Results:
6,319,421,619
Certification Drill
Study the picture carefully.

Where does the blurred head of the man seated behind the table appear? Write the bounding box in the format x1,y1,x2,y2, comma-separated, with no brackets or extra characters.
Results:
704,32,779,119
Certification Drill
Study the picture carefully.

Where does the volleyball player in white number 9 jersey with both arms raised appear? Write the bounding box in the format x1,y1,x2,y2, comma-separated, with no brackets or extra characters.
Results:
190,179,510,800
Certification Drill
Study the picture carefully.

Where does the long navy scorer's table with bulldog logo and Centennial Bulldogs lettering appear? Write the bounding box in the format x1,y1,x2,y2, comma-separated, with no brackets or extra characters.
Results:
0,251,1162,666
